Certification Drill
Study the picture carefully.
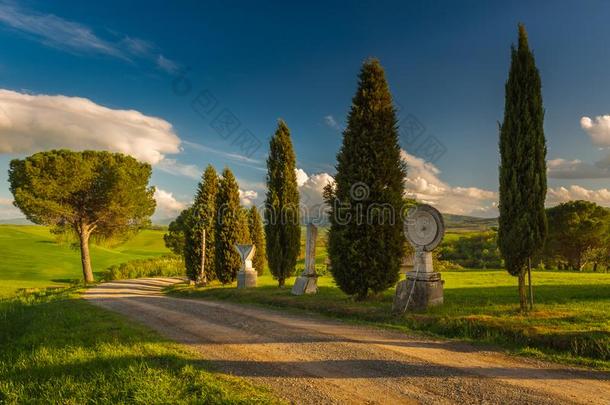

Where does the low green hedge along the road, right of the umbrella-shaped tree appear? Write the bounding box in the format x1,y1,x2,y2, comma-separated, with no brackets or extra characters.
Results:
102,255,185,281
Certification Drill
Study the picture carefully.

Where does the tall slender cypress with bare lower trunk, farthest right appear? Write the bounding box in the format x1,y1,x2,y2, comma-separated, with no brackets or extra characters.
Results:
498,24,547,310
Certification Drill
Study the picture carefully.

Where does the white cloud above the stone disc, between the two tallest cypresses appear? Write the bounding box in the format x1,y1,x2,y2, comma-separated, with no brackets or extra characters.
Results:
401,150,498,216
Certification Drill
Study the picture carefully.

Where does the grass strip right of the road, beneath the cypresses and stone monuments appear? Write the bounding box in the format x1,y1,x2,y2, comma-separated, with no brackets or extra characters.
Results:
170,270,610,370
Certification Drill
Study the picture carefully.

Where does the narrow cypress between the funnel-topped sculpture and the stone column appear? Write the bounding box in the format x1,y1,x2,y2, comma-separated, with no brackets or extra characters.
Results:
265,120,301,287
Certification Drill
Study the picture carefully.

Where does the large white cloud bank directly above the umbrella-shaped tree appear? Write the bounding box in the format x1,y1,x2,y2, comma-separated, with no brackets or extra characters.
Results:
0,89,180,164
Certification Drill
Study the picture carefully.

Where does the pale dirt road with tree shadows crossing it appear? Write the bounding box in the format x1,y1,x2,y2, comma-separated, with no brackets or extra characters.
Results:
85,278,610,405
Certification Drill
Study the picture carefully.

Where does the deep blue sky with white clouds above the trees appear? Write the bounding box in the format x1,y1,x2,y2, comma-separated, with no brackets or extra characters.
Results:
0,1,610,218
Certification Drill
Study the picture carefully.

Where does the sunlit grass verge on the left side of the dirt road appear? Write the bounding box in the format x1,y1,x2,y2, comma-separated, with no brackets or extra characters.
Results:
0,288,277,404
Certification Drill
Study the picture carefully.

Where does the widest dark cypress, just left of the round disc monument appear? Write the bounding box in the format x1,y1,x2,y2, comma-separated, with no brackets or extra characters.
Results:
325,59,406,299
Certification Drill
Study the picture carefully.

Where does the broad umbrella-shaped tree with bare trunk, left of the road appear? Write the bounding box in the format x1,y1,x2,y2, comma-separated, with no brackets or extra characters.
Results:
9,150,155,283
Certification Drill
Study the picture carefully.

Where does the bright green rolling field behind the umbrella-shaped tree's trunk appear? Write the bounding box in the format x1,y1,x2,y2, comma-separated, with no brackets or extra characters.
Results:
0,225,169,297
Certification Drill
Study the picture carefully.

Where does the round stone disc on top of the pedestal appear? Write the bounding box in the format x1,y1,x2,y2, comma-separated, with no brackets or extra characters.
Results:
405,204,445,252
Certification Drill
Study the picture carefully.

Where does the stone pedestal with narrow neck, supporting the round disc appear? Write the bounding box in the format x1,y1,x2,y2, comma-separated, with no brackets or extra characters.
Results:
392,251,445,312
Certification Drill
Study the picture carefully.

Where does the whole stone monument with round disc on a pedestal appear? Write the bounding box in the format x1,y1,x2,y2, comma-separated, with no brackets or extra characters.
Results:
393,204,445,312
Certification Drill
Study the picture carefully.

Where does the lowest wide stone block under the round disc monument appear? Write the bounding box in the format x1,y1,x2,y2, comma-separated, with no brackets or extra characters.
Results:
392,272,445,312
